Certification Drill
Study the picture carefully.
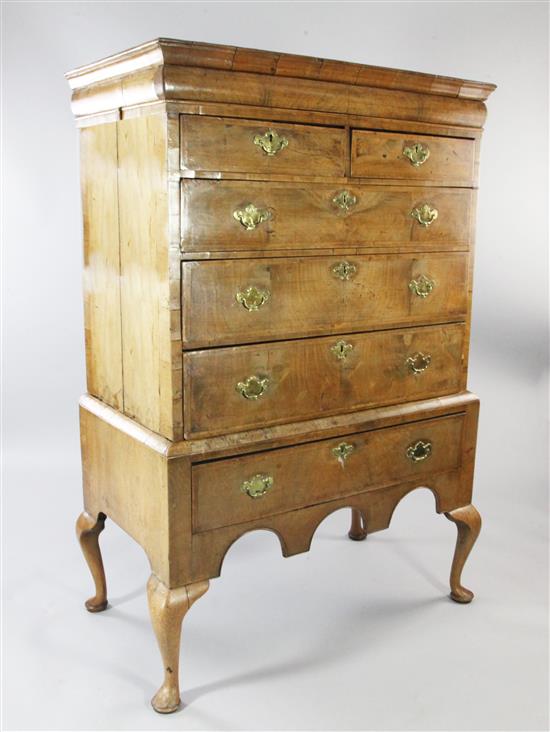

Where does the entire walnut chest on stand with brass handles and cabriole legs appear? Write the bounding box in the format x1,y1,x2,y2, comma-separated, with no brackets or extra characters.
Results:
67,39,494,712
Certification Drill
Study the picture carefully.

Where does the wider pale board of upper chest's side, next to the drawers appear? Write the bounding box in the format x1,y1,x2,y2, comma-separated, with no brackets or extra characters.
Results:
118,115,181,439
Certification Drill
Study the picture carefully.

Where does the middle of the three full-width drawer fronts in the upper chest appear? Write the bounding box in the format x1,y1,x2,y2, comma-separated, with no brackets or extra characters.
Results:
182,253,468,348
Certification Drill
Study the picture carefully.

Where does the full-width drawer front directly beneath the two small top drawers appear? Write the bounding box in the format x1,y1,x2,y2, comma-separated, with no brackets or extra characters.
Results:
181,180,474,252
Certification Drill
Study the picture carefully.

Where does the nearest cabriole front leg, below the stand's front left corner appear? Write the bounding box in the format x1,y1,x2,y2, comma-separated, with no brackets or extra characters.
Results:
147,574,209,714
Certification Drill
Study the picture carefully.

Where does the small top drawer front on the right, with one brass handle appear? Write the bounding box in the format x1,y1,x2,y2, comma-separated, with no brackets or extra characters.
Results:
351,130,475,186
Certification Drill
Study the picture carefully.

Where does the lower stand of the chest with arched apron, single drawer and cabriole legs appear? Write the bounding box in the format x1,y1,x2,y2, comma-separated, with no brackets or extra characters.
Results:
76,394,481,714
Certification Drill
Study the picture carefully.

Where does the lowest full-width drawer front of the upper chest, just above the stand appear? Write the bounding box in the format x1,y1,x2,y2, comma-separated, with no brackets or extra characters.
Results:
183,324,464,437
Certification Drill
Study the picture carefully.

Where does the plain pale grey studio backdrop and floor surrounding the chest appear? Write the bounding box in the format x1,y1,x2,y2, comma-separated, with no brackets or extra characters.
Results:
2,2,548,730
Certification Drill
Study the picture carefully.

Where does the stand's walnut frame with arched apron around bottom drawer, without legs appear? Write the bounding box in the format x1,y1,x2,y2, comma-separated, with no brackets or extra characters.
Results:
76,394,479,589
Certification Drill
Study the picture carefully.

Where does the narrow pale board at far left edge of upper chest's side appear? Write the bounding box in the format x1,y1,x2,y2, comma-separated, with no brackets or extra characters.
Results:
80,124,123,409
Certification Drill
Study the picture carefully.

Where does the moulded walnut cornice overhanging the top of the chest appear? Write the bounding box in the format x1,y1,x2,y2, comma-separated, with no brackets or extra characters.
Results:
67,38,496,128
